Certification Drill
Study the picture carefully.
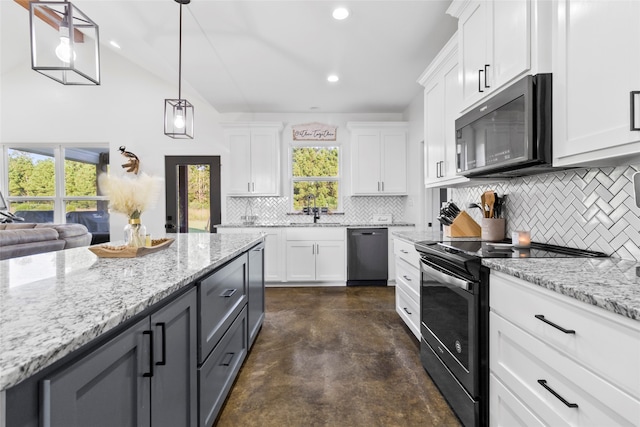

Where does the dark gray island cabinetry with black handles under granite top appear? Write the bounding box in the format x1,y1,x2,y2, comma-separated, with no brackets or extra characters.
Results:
0,234,264,427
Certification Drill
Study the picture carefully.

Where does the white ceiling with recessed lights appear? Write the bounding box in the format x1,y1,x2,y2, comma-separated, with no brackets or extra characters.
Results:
0,0,456,113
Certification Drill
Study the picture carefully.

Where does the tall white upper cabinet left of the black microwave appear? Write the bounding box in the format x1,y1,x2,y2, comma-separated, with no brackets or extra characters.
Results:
418,35,469,188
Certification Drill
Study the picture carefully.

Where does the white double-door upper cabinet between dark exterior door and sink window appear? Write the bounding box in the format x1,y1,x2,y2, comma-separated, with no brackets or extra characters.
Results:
222,123,282,196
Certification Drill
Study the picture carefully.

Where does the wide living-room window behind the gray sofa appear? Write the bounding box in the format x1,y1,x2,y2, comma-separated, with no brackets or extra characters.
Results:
3,145,109,235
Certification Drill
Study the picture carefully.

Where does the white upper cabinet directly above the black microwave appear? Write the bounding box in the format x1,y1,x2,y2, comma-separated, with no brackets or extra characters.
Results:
447,0,551,110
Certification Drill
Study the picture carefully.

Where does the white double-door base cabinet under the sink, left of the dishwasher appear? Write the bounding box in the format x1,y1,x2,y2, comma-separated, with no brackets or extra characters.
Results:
286,227,346,282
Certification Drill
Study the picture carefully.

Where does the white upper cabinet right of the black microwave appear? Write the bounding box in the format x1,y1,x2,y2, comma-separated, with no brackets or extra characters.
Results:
553,0,640,166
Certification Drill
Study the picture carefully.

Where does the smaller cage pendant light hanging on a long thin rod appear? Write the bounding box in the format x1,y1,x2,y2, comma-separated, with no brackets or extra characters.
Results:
164,0,193,139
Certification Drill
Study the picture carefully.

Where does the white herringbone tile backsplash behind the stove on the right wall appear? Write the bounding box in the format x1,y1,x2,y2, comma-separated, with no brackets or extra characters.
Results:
452,166,640,261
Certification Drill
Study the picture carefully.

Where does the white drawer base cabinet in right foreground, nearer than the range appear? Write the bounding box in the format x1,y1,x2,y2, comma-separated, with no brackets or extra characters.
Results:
489,272,640,426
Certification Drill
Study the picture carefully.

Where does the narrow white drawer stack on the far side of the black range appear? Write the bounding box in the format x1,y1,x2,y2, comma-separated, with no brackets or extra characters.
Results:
393,238,420,340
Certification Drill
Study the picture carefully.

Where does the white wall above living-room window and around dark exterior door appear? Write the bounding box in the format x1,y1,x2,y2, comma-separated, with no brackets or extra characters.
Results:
0,2,228,237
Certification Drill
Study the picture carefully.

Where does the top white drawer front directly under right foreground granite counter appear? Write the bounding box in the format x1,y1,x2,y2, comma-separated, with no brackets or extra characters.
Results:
490,272,640,396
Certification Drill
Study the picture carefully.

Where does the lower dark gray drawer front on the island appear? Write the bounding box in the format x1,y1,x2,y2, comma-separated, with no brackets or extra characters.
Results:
198,308,247,426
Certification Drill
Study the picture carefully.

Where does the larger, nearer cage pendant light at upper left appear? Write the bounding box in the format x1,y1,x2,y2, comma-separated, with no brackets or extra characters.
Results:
29,0,100,85
